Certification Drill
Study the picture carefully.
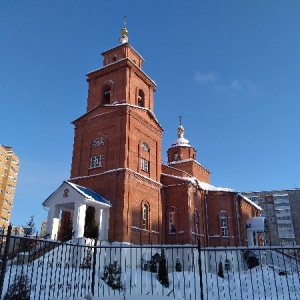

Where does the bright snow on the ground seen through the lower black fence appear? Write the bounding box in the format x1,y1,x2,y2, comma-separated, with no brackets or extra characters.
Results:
2,243,300,300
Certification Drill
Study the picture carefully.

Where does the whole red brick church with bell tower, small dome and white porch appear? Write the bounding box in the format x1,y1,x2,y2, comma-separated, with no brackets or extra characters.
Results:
43,26,261,247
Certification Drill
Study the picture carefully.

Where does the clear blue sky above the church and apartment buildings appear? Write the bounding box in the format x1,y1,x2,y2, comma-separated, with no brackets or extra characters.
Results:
0,0,300,229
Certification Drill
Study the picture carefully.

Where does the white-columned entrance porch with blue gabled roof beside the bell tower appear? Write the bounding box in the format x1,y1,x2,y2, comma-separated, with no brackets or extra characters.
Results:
43,181,111,241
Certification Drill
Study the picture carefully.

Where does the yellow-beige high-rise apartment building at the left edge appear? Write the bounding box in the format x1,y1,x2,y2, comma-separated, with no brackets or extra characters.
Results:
0,145,20,232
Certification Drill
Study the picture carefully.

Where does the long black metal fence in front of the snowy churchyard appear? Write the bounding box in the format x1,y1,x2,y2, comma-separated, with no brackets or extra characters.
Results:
0,226,300,300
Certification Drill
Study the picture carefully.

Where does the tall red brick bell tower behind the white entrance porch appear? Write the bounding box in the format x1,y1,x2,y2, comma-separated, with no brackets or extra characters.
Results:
71,22,163,243
